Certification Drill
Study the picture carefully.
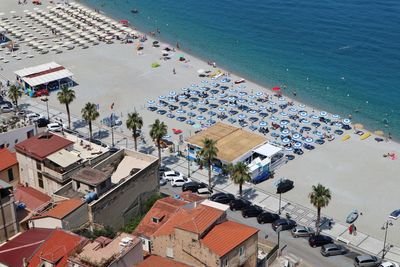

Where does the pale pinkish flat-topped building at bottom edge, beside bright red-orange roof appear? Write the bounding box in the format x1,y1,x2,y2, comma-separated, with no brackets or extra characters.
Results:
68,233,143,267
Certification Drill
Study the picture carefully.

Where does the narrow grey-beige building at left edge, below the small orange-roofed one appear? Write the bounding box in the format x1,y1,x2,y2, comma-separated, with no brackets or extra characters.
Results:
0,180,18,242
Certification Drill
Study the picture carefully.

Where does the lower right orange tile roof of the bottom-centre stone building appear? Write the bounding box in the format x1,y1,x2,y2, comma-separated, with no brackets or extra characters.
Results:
201,221,259,257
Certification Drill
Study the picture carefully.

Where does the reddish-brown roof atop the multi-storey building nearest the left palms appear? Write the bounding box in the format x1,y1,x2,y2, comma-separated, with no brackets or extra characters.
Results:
15,133,74,160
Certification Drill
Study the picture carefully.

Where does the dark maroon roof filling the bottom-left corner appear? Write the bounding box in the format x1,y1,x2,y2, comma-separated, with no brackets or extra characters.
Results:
0,228,55,267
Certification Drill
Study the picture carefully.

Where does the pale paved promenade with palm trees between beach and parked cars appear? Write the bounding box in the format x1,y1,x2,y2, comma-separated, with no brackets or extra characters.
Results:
24,99,400,262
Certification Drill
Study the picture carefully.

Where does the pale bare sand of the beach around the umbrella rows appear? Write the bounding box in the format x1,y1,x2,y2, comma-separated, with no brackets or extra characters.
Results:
0,0,400,248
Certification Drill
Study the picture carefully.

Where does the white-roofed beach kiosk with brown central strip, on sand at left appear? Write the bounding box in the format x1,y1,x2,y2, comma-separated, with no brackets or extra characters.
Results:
14,62,74,97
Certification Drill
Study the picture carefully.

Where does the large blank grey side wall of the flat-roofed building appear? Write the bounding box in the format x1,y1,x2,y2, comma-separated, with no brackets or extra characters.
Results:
89,157,159,229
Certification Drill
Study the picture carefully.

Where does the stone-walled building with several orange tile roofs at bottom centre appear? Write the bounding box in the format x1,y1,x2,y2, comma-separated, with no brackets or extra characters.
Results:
138,200,258,267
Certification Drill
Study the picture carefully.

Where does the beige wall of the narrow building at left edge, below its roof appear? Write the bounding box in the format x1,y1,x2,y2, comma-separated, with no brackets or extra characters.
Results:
0,195,18,243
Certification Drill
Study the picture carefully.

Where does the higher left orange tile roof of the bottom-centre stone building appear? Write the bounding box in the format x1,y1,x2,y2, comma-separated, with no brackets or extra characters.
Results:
154,204,225,236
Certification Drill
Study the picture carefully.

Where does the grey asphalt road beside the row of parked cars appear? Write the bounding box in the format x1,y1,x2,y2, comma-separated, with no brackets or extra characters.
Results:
161,184,358,267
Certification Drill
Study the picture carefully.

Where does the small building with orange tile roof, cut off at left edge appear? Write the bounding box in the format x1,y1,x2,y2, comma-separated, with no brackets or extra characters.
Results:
0,148,19,187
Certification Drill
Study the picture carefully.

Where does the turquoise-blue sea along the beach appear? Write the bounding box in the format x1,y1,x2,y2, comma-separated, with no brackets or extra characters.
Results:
81,0,400,140
